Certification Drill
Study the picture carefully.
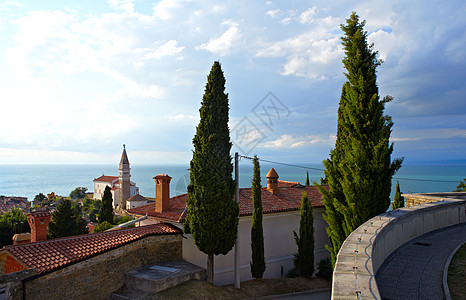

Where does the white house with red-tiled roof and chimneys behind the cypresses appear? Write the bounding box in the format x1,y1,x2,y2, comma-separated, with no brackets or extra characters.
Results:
127,168,330,285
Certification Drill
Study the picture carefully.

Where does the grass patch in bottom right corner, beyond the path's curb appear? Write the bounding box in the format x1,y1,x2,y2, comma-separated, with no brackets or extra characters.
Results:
448,244,466,300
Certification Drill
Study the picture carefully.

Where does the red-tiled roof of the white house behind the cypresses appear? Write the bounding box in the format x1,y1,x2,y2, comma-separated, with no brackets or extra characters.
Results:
128,185,324,223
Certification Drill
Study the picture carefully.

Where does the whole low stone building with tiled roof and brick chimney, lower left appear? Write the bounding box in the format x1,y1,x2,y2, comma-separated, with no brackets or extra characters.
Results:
0,211,182,300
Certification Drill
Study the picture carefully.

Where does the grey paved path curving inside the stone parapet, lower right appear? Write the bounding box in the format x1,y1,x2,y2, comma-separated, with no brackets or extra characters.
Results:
376,223,466,300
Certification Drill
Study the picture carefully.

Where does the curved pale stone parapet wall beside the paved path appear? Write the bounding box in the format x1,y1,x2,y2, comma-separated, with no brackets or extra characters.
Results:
332,198,466,299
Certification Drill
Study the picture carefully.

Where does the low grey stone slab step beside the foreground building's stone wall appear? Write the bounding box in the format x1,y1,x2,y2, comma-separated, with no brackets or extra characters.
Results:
125,260,206,293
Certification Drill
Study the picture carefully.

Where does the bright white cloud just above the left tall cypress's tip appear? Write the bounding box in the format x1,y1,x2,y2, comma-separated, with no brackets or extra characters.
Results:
196,20,242,53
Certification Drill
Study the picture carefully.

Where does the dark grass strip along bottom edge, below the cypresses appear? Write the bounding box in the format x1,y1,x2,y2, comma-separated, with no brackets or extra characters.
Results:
157,277,331,300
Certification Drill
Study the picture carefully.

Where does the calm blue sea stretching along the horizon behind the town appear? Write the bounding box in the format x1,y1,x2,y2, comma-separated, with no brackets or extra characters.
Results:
0,163,466,200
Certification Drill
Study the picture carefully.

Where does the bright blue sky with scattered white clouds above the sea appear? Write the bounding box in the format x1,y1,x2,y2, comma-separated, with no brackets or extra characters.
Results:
0,0,466,164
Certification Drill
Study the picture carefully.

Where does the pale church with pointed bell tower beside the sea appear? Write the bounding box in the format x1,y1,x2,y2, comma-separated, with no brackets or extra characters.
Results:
93,145,139,209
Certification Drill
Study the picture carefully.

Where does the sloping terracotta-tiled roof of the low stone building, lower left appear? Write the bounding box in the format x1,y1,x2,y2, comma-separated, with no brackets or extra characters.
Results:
3,223,182,275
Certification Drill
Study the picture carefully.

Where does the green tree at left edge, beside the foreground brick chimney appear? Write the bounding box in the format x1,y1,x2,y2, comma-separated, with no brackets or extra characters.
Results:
0,207,31,249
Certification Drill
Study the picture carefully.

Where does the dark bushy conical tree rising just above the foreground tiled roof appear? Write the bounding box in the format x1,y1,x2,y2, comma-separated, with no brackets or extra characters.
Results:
48,199,89,238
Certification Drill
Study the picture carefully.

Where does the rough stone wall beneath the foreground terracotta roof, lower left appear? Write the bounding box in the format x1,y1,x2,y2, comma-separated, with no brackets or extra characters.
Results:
25,234,182,300
